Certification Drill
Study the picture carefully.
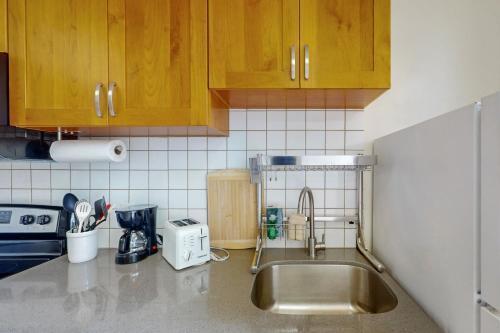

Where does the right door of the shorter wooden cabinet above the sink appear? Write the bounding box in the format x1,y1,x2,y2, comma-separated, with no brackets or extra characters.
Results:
300,0,390,88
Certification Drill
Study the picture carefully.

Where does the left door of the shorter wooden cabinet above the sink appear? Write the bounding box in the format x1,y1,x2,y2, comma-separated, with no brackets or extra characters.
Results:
209,0,299,88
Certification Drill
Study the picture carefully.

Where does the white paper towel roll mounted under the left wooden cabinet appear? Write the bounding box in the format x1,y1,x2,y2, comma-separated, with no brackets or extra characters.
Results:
50,140,127,162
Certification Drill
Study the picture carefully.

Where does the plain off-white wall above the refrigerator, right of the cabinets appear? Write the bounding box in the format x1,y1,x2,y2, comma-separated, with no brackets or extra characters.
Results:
365,0,500,142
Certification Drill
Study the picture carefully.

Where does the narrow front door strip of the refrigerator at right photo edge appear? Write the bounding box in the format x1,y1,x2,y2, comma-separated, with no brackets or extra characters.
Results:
478,93,500,333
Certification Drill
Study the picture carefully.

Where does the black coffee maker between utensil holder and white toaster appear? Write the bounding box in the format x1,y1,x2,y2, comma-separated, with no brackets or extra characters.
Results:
115,205,158,264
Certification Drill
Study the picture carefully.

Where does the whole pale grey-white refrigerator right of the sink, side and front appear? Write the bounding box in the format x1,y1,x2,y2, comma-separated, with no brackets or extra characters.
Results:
372,93,500,333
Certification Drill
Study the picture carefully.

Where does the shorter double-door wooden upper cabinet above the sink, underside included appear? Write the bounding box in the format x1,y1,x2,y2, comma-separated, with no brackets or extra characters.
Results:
208,0,390,109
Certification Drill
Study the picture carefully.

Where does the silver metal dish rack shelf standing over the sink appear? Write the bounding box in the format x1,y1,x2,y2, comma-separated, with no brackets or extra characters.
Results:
249,154,385,273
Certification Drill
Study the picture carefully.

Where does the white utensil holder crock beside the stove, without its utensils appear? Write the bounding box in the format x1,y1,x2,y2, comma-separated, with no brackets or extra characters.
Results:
66,230,97,264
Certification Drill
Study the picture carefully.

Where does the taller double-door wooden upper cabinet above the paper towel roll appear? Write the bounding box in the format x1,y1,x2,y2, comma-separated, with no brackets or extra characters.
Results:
4,0,229,135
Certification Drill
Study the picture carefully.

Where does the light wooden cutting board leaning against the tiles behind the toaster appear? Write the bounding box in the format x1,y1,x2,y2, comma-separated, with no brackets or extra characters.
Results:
207,169,257,249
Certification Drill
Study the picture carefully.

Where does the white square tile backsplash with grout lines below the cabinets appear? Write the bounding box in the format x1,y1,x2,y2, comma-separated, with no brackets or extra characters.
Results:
0,109,364,247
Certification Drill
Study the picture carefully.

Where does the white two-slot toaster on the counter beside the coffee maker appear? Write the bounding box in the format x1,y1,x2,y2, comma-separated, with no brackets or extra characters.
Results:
162,219,210,270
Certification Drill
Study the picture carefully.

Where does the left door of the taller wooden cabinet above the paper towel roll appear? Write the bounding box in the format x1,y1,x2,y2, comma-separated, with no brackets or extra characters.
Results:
8,0,108,127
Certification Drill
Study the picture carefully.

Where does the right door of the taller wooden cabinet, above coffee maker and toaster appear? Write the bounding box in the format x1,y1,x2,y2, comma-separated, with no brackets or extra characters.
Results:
109,0,208,126
